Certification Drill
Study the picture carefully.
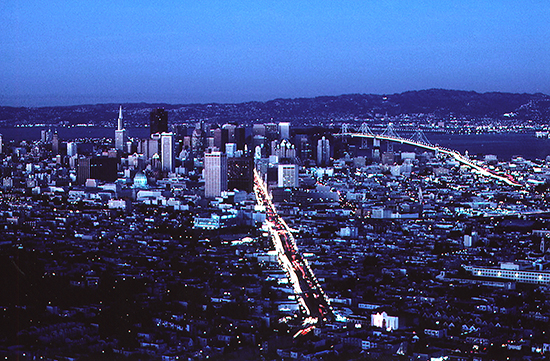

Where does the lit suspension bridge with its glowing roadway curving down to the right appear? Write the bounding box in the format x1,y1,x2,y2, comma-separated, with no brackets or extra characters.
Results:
341,123,522,187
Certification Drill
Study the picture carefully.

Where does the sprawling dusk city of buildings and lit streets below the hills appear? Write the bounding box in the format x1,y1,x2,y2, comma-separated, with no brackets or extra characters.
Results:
0,117,550,361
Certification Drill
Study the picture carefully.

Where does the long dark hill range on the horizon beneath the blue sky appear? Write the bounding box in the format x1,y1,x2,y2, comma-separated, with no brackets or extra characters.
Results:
0,89,550,126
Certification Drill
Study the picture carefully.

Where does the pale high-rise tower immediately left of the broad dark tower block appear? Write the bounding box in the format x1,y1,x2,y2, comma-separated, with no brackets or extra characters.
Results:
204,151,227,198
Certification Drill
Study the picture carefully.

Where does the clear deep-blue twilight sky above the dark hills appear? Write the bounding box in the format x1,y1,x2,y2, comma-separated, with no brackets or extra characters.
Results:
0,0,550,106
